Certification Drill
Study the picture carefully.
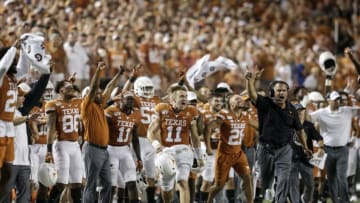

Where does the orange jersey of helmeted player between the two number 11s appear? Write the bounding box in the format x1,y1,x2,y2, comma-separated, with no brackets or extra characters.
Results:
134,96,160,137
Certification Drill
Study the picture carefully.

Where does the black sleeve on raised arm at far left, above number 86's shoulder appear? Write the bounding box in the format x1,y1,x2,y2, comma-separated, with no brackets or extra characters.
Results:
19,74,50,115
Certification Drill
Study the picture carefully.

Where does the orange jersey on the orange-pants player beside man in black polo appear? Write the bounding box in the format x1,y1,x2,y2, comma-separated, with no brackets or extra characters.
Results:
217,110,250,153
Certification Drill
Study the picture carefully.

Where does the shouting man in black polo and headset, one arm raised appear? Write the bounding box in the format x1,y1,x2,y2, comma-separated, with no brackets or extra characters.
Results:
245,70,311,203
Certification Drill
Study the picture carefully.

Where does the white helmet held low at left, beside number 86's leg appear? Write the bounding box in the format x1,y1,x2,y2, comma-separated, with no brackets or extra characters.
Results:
38,163,57,187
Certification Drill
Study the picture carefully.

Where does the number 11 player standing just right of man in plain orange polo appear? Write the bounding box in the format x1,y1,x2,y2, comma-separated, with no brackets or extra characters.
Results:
105,91,142,203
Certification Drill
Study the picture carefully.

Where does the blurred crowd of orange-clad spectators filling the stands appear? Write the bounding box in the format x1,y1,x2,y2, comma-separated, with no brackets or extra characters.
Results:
0,0,360,96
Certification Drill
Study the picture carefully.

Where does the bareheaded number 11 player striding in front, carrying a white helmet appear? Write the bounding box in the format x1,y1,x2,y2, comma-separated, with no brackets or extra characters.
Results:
147,84,204,203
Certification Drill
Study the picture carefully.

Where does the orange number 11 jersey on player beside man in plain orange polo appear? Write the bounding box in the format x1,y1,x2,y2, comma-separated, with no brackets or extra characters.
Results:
105,105,141,146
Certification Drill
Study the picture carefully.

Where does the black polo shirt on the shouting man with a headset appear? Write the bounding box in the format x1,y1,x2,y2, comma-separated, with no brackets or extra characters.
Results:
255,95,302,147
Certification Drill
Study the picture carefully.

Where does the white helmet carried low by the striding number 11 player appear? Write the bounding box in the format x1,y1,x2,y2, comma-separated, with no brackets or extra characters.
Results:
155,152,176,177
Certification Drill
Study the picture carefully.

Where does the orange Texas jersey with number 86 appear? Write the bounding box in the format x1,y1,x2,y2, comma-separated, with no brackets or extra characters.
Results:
45,98,82,141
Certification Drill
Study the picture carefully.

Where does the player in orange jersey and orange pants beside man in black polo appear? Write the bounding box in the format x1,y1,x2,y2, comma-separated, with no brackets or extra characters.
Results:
208,94,257,203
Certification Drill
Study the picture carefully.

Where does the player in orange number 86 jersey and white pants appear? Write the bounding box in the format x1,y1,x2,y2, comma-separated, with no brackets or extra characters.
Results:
45,80,83,203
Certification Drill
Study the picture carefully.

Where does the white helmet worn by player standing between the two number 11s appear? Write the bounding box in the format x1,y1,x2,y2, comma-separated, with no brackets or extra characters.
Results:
134,76,155,98
